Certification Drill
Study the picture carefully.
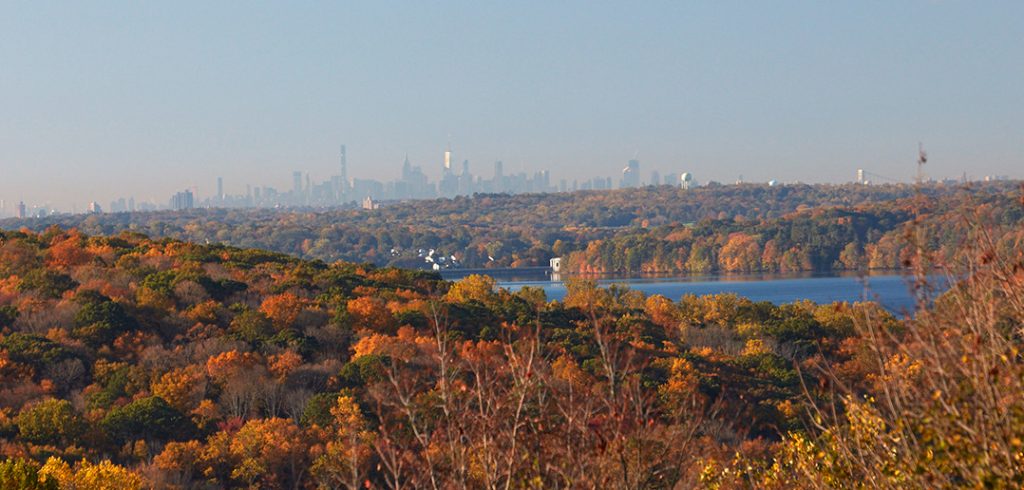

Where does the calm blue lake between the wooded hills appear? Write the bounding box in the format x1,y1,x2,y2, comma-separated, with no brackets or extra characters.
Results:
436,270,945,314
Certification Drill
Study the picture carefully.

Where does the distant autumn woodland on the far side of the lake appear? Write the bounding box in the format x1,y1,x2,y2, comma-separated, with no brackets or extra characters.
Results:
0,182,1024,273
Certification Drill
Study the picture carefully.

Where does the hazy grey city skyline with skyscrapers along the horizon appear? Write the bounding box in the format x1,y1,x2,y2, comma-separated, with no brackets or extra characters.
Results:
0,140,1018,219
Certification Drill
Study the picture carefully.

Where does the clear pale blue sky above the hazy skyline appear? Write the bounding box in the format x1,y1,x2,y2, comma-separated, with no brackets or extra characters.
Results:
0,0,1024,214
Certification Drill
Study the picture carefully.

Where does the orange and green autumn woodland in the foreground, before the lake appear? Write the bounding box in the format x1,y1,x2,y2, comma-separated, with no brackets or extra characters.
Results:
0,193,1024,489
